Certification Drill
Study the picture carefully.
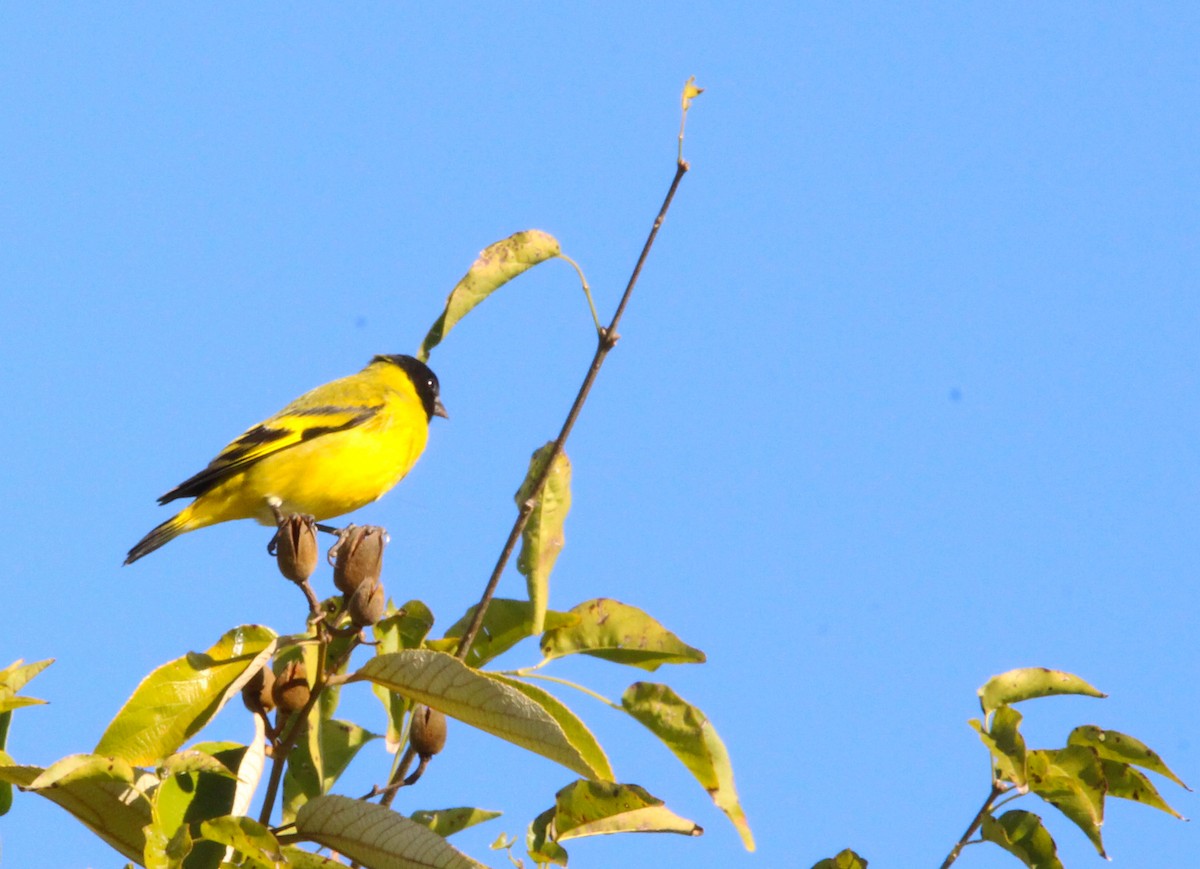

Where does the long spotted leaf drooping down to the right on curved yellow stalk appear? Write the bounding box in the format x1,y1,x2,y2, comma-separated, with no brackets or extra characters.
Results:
620,682,755,851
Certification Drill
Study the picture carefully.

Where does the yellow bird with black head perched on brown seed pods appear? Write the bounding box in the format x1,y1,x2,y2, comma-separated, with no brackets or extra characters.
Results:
125,355,449,564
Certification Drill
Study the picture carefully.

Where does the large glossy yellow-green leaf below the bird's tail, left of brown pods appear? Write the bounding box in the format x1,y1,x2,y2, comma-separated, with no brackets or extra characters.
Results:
96,625,275,766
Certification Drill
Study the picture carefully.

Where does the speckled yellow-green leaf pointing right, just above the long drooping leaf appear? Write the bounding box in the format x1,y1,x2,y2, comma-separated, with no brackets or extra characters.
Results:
541,598,704,672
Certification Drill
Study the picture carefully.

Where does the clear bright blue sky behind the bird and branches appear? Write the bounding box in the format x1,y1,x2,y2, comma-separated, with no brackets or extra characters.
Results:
0,2,1200,868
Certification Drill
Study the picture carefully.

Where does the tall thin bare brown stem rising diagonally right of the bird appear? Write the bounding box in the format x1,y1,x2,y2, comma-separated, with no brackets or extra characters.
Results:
455,157,689,660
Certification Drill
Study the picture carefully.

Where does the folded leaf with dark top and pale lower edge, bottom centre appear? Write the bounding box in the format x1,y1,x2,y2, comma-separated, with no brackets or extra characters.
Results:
554,779,704,841
